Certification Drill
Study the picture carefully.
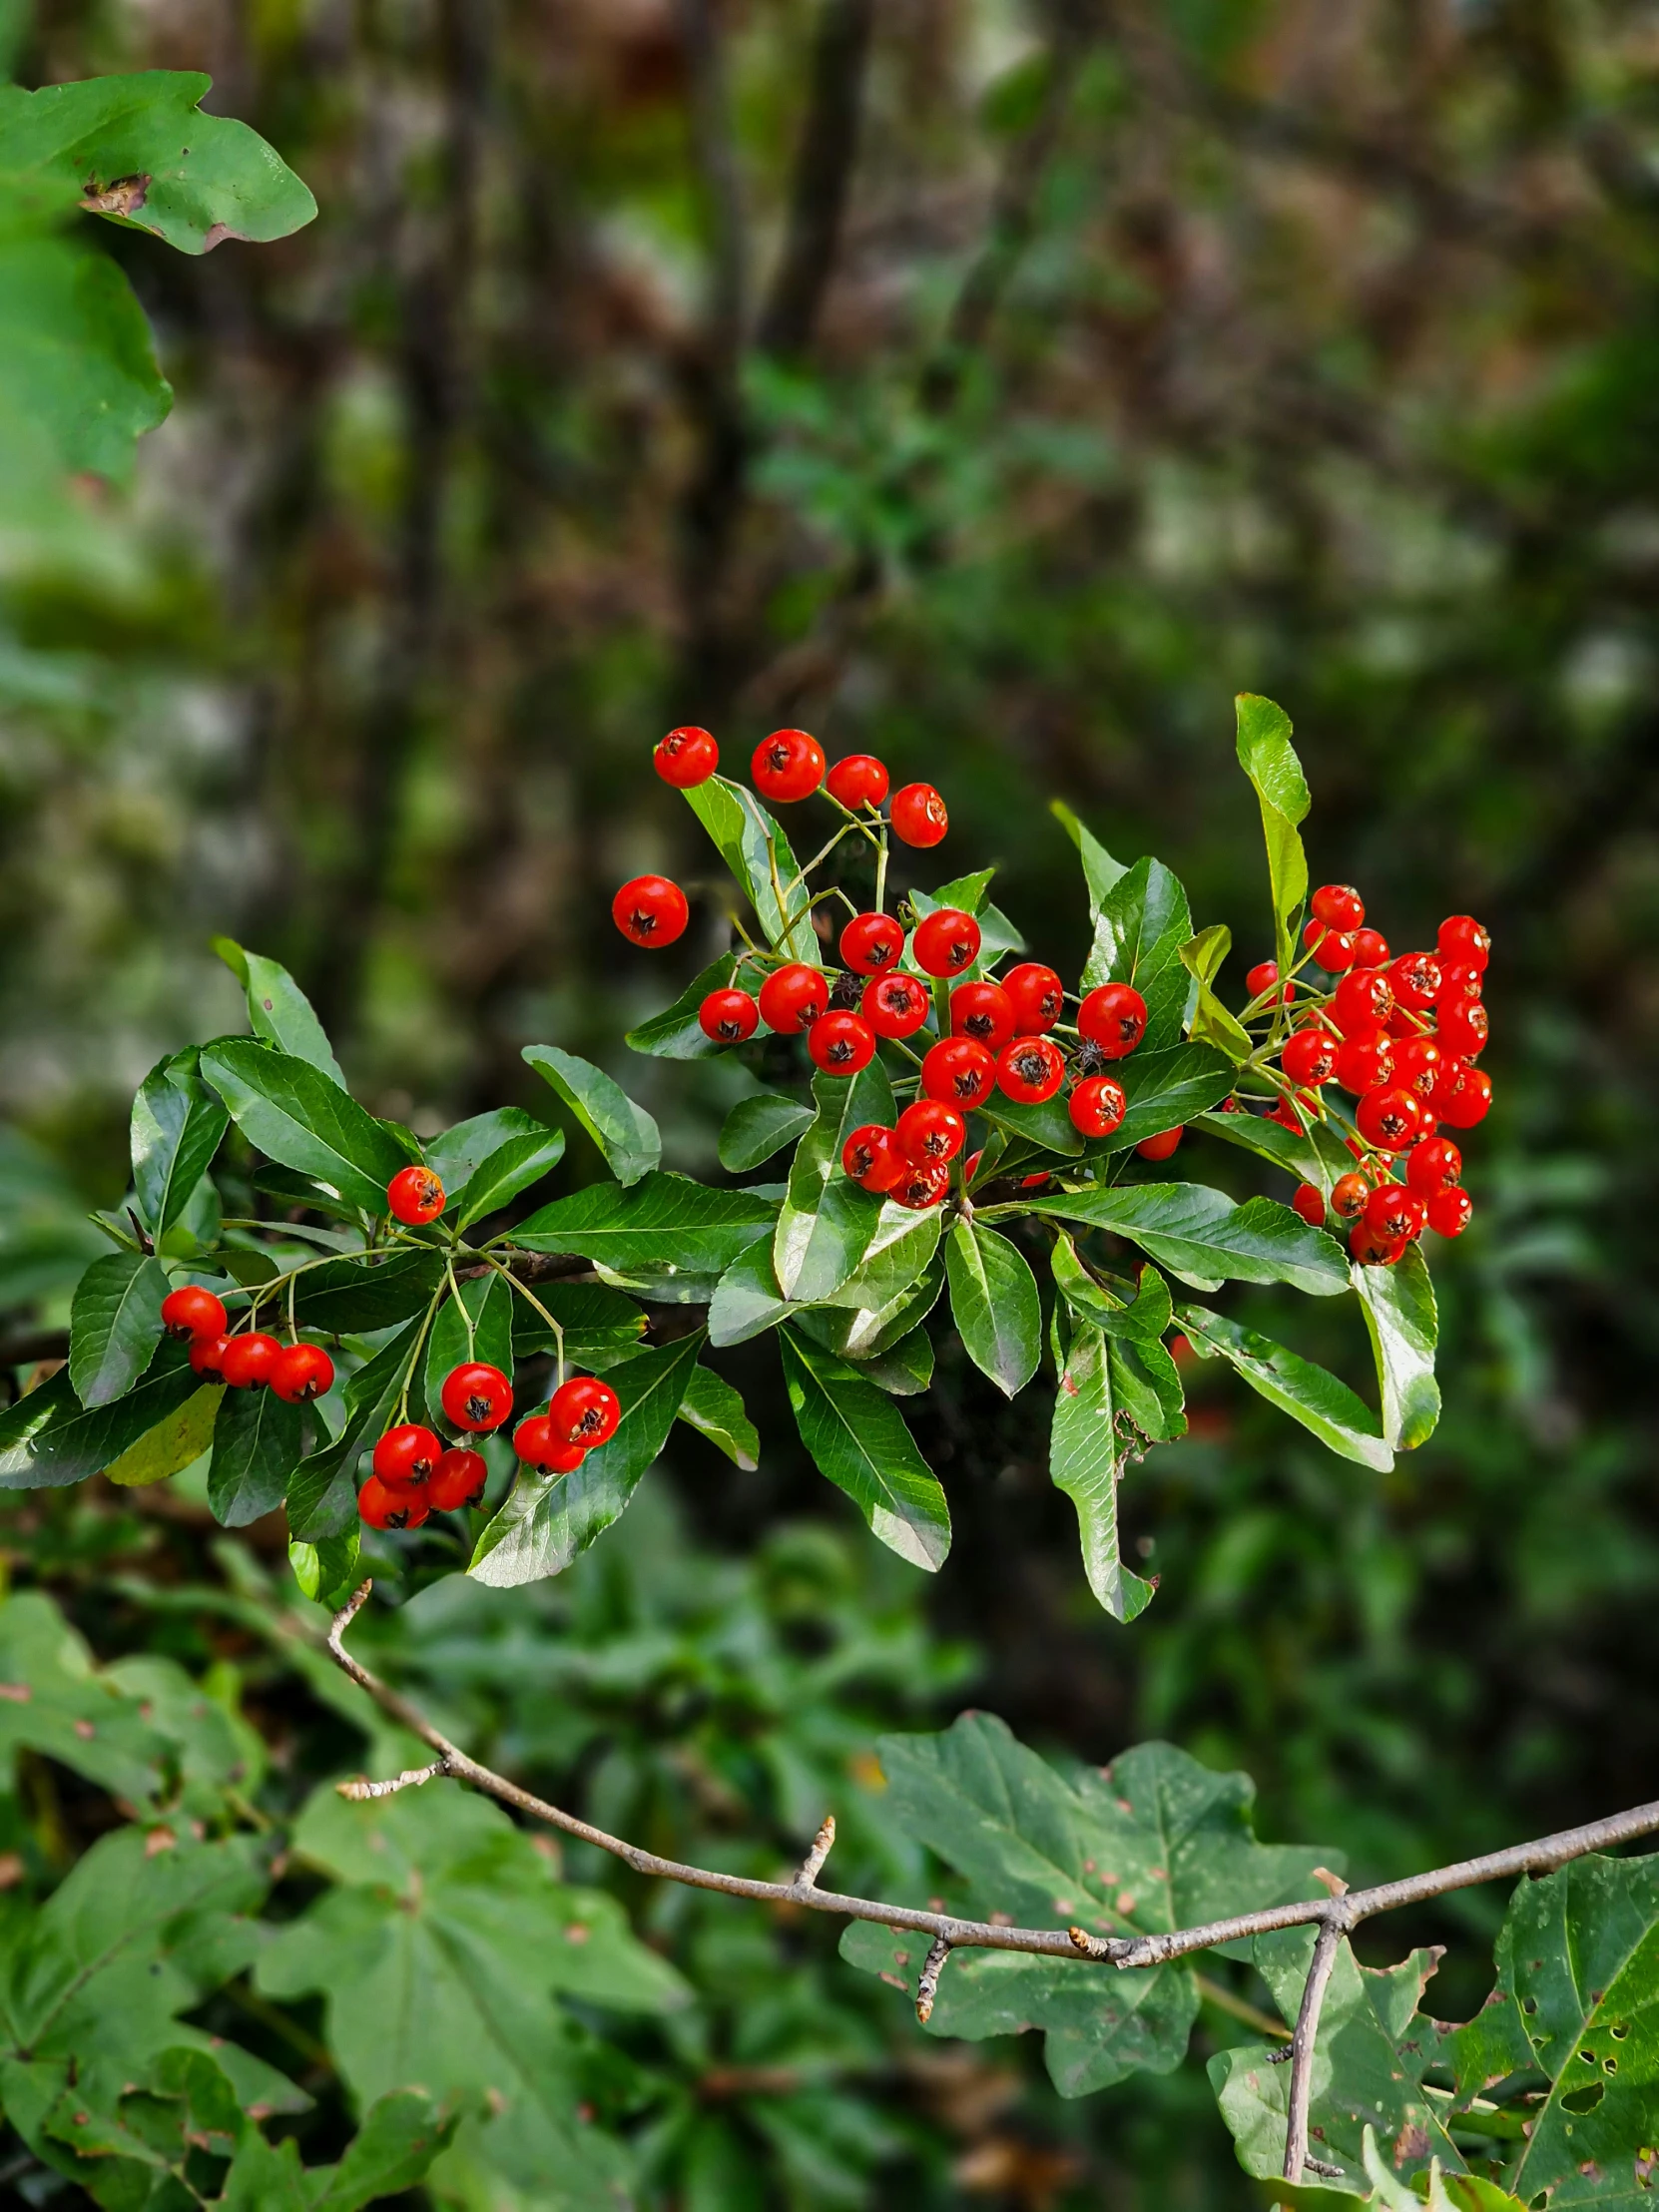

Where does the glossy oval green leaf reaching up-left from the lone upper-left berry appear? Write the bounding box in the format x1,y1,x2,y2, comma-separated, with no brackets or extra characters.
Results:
202,1037,409,1215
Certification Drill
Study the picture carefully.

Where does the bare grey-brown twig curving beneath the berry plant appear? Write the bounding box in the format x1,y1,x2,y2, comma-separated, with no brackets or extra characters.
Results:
325,1581,1659,2183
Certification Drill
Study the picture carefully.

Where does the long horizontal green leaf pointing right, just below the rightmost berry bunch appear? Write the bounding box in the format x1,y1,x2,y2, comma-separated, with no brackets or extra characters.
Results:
1021,1184,1348,1299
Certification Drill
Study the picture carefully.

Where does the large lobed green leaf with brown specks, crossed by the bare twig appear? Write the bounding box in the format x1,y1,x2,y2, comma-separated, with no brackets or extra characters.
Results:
840,1712,1332,2096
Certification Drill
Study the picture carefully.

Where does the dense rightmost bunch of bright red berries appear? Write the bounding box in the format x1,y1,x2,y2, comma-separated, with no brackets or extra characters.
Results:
1246,882,1491,1268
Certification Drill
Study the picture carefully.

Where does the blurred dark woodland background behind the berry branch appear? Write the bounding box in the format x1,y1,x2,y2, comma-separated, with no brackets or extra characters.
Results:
0,0,1659,2212
